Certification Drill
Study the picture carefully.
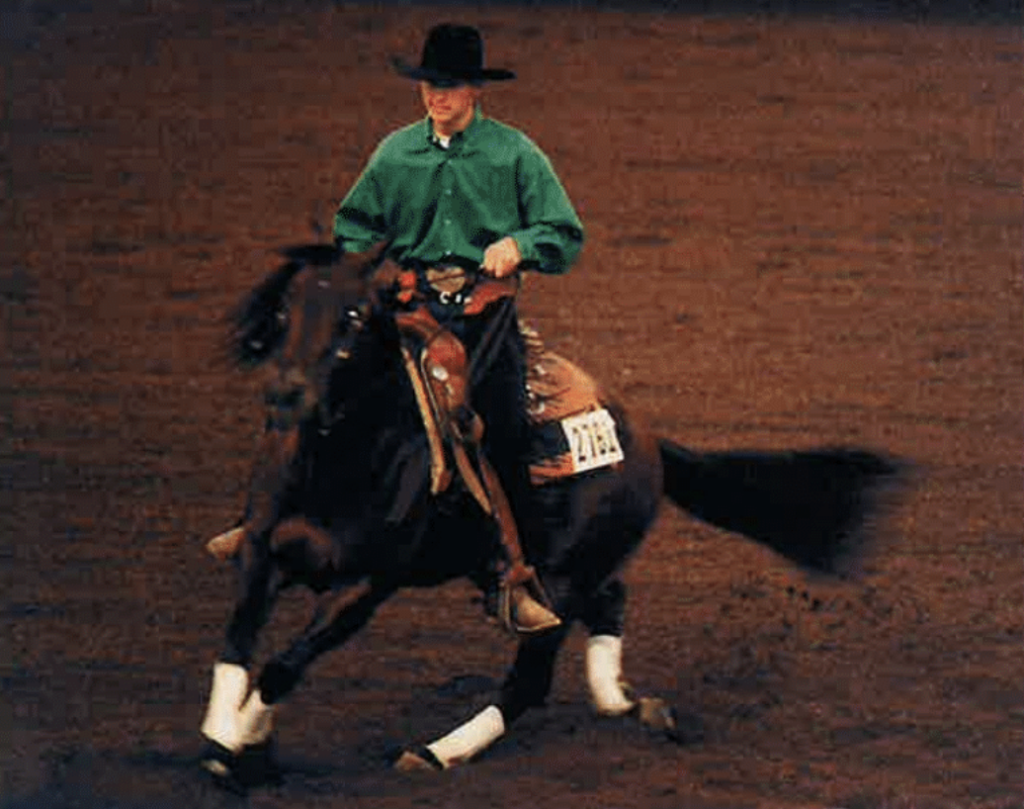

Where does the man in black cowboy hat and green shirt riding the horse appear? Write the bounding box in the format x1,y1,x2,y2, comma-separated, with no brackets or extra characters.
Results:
334,25,584,634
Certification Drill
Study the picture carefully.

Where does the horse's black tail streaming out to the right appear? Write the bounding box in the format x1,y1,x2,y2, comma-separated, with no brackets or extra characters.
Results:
659,440,902,577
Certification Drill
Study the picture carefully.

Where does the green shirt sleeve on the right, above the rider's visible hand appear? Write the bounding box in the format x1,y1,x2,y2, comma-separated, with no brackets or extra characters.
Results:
509,143,584,274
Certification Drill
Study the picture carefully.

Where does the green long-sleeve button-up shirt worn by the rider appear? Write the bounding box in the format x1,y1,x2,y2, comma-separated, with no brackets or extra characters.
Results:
334,111,584,273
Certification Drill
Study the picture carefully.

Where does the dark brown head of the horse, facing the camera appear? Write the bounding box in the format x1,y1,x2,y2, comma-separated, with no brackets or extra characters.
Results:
253,245,383,427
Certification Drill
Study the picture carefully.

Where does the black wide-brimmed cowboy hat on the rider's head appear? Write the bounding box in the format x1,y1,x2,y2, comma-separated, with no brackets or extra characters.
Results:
391,23,515,86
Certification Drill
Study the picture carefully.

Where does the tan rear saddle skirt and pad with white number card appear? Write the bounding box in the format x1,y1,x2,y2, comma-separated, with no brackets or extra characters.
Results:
520,326,626,485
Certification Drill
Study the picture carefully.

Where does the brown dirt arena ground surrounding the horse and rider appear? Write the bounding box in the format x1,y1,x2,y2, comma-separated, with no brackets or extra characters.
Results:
0,0,1024,809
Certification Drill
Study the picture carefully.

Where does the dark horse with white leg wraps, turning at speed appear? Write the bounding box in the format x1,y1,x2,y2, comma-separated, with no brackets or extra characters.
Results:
197,246,897,784
